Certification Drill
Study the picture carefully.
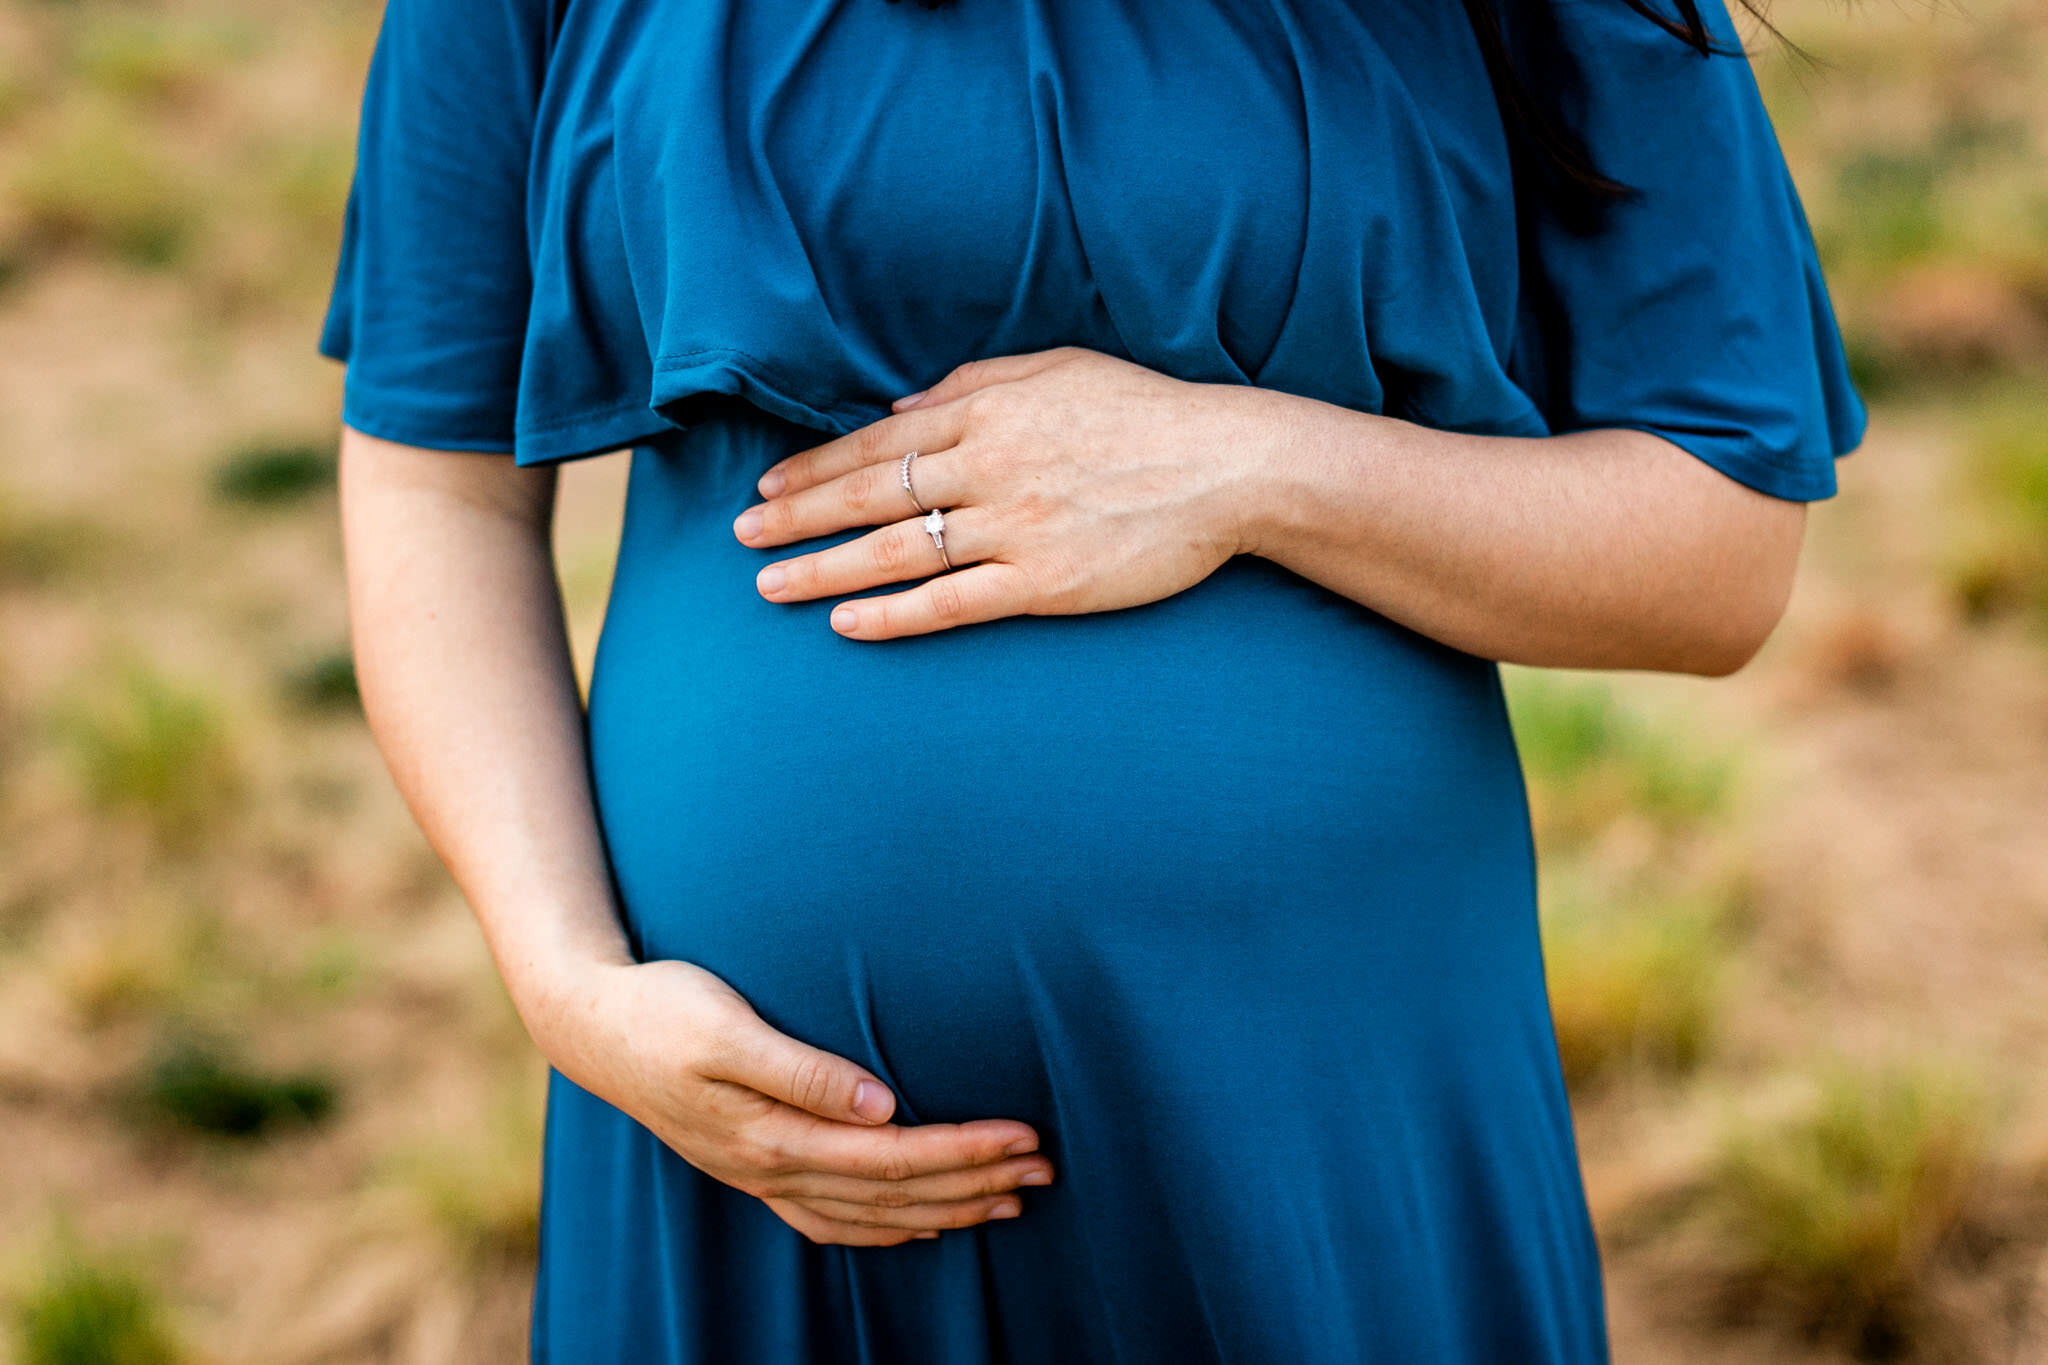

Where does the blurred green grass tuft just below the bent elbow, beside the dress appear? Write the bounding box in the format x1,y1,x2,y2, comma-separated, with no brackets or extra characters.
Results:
1503,667,1737,841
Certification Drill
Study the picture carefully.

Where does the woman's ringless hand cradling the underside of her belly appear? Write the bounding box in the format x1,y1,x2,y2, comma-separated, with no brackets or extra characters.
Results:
520,962,1053,1246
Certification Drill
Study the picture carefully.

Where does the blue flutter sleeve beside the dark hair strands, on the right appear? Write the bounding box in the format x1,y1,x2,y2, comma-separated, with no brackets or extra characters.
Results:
1503,0,1866,501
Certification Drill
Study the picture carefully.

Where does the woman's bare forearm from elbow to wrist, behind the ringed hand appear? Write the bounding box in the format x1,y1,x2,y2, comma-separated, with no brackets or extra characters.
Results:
1241,391,1804,675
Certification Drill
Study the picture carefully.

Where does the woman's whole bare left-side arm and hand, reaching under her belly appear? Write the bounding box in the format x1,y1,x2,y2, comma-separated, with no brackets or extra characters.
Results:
340,430,1051,1244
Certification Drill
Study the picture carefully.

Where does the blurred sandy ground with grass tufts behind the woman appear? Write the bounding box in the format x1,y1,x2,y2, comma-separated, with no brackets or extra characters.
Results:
0,0,2048,1365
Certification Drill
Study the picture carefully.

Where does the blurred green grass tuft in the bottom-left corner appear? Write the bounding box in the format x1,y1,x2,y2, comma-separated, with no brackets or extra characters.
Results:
14,1240,184,1365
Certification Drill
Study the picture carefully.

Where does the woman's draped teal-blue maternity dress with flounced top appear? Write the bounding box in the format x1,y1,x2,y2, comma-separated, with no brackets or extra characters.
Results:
322,0,1864,1365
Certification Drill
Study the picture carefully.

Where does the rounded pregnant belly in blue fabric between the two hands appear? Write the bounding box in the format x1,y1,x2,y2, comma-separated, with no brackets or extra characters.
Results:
590,422,1540,1121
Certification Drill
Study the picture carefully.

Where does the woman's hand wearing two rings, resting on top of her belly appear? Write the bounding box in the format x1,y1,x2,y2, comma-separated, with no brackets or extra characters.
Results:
733,346,1282,641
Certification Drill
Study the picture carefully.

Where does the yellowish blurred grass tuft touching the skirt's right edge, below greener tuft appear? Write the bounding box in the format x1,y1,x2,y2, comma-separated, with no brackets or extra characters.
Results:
1542,874,1731,1089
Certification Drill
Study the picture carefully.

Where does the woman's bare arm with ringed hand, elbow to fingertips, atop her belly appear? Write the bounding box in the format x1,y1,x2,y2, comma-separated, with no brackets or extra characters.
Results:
735,348,1804,675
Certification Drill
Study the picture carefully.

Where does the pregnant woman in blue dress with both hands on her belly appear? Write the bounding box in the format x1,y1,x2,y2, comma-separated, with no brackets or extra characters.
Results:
322,0,1864,1365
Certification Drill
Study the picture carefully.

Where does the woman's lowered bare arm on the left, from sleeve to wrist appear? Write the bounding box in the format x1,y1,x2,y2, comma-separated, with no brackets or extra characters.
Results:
340,430,631,1039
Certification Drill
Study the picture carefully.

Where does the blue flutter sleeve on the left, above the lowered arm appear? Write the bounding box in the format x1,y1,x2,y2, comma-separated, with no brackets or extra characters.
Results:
319,0,551,452
